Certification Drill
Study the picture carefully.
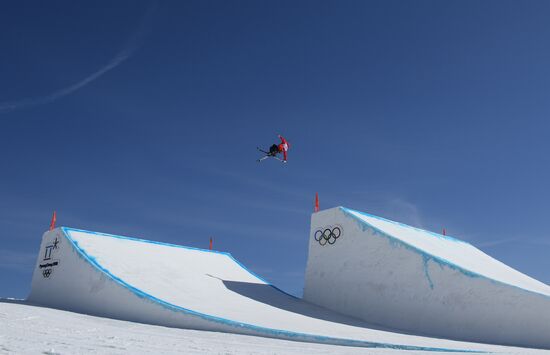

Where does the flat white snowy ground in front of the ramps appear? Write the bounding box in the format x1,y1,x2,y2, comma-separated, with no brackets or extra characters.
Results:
0,300,550,355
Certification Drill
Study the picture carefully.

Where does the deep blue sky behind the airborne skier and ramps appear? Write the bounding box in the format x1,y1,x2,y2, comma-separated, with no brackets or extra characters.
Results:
0,0,550,297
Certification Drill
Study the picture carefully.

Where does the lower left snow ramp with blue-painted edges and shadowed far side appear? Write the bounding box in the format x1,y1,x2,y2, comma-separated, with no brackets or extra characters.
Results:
28,227,500,352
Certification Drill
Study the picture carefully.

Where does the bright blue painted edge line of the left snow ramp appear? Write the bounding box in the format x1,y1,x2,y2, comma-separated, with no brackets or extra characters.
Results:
61,227,485,353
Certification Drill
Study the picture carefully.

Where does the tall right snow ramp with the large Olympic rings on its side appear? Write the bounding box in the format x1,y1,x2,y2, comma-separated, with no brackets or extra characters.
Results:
304,207,550,349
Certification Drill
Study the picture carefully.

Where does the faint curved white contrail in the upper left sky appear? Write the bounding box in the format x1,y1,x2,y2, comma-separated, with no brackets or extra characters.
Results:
0,3,156,113
